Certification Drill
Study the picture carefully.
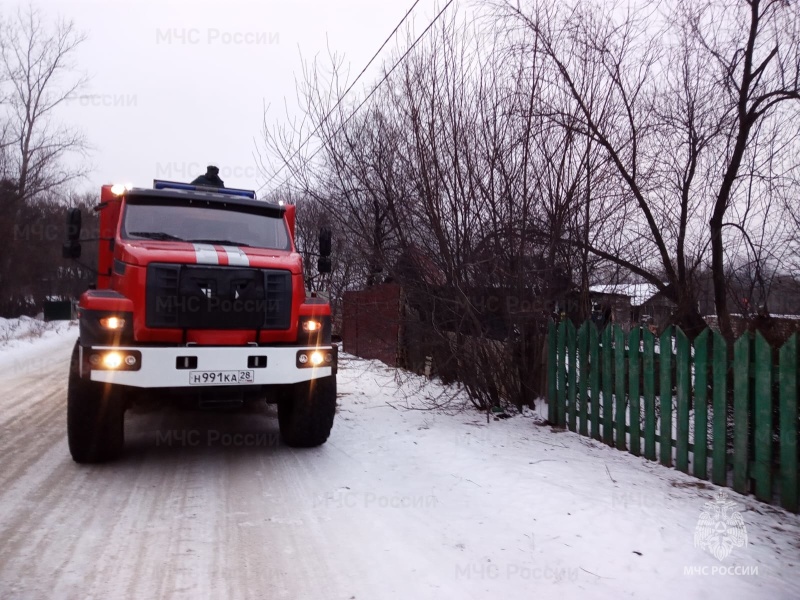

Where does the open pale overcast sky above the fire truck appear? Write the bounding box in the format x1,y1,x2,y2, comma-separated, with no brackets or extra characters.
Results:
47,0,446,195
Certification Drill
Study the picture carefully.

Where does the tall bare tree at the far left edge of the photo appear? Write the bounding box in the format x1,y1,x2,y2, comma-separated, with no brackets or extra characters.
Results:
0,7,85,316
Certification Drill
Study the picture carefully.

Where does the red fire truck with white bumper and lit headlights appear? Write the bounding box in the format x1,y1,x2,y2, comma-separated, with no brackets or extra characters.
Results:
63,180,337,463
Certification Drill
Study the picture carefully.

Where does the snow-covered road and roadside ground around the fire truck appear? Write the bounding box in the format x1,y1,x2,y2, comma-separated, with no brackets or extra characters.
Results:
0,325,800,600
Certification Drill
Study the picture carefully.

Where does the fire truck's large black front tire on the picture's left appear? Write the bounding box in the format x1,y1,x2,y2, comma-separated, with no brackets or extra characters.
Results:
67,342,125,463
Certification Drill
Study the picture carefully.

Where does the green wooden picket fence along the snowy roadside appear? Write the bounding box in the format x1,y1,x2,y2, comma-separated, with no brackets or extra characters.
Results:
547,320,800,512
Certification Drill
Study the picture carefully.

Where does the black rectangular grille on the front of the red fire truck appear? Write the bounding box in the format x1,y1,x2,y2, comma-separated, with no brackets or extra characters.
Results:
145,263,292,329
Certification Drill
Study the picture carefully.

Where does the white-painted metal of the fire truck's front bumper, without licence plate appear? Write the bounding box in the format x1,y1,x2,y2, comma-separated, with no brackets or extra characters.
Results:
86,346,335,389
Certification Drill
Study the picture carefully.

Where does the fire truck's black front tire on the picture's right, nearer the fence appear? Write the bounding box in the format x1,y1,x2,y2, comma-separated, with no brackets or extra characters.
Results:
278,375,336,448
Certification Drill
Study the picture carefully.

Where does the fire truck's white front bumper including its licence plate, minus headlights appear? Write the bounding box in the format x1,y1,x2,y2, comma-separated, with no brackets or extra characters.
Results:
80,345,338,388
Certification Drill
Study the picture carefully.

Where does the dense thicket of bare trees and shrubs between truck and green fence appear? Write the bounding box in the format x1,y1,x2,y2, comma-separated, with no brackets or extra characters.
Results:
264,0,797,408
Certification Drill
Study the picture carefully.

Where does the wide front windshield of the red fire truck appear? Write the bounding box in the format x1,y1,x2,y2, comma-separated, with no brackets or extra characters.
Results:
122,203,291,250
